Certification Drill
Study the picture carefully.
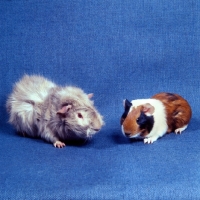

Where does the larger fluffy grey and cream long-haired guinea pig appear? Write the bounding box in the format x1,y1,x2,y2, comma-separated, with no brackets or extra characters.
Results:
6,75,104,148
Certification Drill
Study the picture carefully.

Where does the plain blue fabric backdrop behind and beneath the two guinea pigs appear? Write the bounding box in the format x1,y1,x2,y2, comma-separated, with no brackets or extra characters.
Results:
0,0,200,200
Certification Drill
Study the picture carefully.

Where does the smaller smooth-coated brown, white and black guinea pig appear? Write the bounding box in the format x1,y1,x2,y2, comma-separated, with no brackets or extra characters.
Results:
121,93,192,144
